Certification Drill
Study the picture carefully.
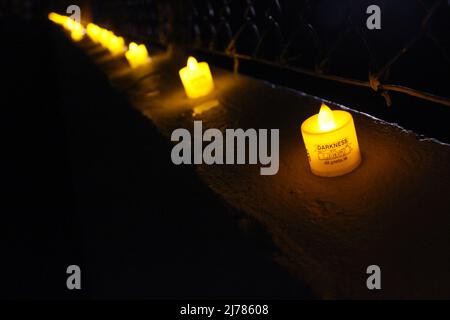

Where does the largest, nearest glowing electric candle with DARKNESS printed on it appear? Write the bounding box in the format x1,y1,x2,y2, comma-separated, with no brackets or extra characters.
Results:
301,104,361,177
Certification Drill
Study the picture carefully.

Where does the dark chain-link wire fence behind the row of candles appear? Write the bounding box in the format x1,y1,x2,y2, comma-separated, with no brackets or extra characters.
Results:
90,0,450,106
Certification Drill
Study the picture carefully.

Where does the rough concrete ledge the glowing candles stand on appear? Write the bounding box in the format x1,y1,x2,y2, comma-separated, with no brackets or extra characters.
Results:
81,40,450,299
